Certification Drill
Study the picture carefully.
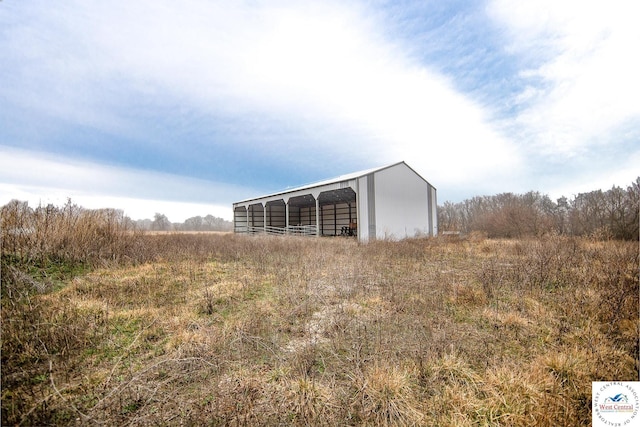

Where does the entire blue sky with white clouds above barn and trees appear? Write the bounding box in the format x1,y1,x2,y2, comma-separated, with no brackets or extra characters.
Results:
0,0,640,221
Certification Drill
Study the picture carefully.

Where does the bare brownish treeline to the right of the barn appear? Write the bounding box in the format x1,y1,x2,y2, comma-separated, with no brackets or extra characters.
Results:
438,177,640,240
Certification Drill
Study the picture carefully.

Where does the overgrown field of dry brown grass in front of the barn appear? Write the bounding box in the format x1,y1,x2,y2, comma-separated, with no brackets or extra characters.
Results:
2,234,640,426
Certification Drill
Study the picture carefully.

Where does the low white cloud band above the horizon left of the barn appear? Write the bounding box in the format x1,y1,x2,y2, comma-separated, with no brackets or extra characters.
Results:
0,146,248,222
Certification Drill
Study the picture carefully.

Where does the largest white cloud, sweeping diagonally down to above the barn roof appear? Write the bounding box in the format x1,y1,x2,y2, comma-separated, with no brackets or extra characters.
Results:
2,0,522,197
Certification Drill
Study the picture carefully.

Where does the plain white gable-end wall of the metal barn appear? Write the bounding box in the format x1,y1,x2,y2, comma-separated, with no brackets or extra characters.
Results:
375,164,430,239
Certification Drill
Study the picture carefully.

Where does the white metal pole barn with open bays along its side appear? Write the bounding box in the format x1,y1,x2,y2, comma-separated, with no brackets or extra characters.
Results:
233,162,438,242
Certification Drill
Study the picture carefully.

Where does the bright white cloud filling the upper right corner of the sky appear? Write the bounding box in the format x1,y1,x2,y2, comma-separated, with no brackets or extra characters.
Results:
489,0,640,156
